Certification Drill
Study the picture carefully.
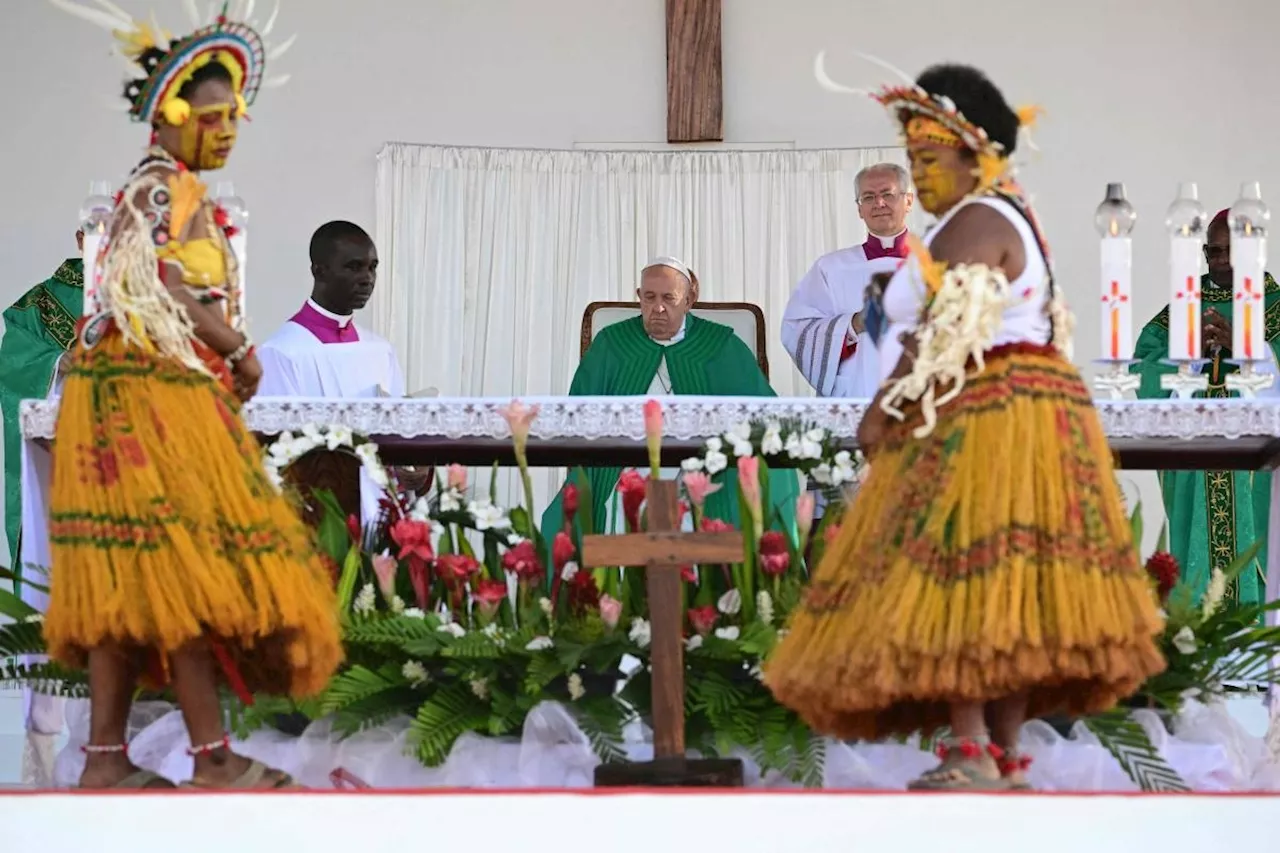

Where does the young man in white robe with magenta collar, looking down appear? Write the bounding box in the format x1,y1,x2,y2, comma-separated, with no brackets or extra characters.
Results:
257,222,411,524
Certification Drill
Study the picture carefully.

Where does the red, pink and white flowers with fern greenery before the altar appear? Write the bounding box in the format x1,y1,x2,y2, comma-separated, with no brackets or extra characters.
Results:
0,401,1280,790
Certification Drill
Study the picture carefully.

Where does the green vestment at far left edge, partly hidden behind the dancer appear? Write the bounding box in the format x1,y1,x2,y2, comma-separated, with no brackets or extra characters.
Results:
0,257,84,570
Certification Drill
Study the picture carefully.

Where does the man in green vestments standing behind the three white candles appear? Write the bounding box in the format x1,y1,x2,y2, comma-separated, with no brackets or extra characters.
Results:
1133,210,1280,603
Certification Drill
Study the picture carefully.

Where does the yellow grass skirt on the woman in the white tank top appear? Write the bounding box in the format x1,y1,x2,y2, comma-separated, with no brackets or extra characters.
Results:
765,346,1165,739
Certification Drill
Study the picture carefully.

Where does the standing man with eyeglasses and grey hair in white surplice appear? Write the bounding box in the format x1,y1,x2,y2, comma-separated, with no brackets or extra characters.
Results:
782,163,913,398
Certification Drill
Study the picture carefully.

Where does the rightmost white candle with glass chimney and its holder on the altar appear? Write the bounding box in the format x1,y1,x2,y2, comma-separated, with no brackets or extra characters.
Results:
1226,181,1275,397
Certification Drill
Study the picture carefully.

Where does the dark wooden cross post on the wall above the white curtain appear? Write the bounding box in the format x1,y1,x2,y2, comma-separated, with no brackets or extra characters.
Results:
667,0,724,142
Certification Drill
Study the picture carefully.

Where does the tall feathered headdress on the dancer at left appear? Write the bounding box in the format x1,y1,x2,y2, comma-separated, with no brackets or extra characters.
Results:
49,0,297,124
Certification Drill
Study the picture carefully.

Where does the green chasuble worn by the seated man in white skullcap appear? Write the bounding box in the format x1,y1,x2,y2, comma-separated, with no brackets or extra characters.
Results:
541,314,799,542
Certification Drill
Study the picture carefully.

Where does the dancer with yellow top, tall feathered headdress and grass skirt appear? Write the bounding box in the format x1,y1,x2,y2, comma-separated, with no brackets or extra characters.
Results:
45,1,342,788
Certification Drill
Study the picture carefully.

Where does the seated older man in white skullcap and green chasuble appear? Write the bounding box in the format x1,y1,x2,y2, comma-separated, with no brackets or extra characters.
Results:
543,257,799,533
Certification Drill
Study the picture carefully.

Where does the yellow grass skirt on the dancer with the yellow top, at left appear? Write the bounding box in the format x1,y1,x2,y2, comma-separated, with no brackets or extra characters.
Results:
45,330,342,697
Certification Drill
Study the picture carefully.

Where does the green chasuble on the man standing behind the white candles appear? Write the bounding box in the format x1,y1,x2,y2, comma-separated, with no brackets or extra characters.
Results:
1133,273,1280,602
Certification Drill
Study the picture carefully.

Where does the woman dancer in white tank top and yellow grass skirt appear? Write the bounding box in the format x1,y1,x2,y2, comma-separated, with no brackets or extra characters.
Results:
767,59,1164,790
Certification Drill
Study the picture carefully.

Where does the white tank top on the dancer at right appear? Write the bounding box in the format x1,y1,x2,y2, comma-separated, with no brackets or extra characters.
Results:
879,196,1052,382
